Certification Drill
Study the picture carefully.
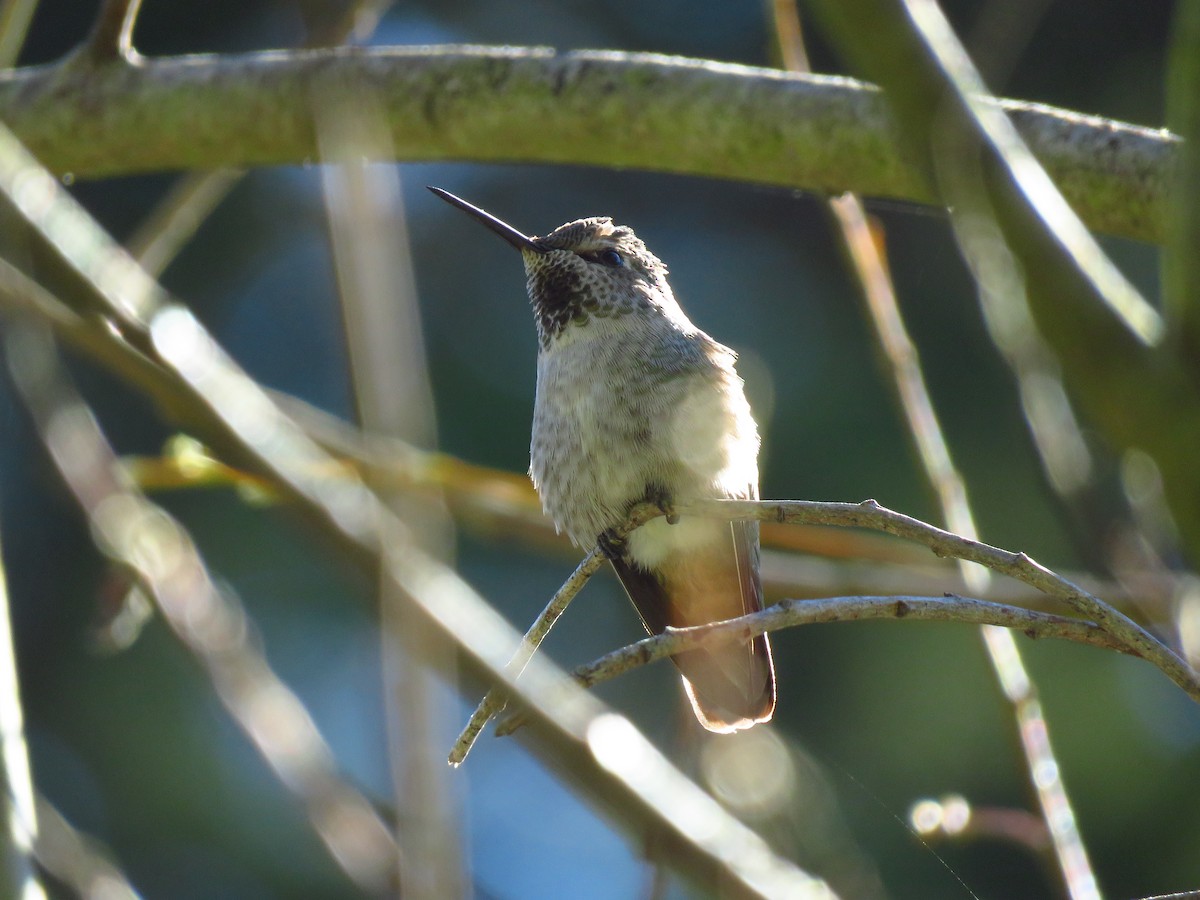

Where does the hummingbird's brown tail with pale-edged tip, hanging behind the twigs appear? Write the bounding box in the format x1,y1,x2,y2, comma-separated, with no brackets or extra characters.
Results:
612,522,775,733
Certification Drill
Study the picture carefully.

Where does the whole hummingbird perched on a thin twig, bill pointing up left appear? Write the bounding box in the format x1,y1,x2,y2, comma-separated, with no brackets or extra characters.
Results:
430,187,775,733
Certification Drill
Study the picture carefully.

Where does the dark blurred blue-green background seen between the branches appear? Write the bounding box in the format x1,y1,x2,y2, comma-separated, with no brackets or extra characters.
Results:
0,0,1200,898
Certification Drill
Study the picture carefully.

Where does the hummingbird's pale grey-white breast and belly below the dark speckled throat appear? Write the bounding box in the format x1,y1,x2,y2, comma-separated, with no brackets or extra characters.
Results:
530,312,758,568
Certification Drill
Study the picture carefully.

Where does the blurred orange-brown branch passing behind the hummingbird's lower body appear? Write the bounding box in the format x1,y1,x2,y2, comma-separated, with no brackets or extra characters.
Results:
110,417,1187,619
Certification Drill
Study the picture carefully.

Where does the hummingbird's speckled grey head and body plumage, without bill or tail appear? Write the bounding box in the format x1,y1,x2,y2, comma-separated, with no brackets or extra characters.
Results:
523,218,758,547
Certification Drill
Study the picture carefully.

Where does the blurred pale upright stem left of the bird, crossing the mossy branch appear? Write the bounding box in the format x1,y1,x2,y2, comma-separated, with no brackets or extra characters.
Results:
313,82,466,900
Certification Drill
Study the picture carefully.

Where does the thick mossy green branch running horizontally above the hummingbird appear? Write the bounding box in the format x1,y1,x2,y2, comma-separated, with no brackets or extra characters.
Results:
0,47,1176,241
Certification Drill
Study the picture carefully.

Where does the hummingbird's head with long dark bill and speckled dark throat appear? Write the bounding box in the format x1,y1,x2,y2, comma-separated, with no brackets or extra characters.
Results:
430,187,695,349
